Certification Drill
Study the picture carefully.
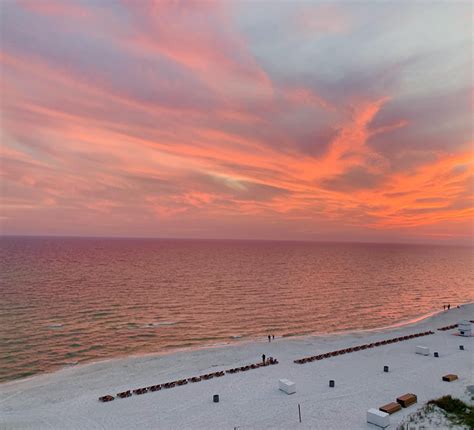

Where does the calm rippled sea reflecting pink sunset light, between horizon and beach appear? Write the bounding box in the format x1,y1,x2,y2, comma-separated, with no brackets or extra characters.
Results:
0,237,474,381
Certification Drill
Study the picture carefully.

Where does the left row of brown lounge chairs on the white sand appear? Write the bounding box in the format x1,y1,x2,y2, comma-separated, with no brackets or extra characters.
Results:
99,357,278,402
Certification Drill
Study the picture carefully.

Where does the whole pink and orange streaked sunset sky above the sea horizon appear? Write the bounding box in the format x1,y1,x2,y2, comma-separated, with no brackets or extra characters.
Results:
0,0,474,244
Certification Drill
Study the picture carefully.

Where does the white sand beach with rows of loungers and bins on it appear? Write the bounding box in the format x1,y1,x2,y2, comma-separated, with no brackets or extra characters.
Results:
0,304,474,429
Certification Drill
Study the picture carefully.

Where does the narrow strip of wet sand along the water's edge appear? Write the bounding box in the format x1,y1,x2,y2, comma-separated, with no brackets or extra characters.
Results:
0,301,474,388
